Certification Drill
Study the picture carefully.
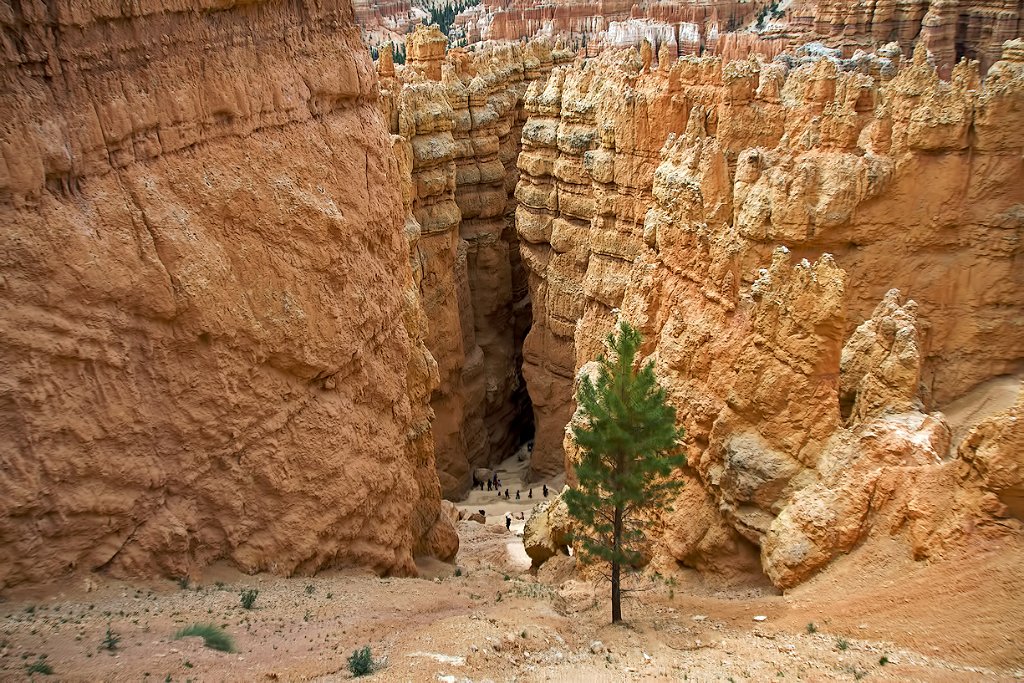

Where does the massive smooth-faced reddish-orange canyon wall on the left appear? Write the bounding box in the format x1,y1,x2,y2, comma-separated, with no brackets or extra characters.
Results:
0,0,458,586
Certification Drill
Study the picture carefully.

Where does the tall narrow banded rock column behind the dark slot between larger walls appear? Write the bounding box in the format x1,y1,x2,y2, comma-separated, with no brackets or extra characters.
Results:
379,27,577,496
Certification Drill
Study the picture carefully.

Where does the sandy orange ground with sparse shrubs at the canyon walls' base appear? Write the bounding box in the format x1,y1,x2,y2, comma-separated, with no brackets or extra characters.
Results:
0,448,1024,683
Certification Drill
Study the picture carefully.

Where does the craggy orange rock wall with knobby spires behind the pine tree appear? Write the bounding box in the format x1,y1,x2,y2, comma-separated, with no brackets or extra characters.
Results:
517,42,1024,588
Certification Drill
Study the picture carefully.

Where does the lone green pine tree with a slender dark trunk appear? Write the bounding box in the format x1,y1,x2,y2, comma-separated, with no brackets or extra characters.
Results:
565,322,686,624
